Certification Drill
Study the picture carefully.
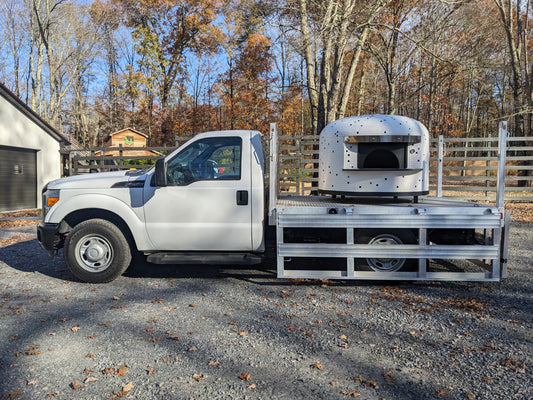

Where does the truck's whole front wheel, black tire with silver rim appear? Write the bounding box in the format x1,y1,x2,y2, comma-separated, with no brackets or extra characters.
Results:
64,219,131,283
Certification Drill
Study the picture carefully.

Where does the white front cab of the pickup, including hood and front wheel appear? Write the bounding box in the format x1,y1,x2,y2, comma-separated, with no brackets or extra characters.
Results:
38,130,264,282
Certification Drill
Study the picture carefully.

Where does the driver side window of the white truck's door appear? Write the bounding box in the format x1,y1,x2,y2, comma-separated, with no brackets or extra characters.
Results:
167,137,242,186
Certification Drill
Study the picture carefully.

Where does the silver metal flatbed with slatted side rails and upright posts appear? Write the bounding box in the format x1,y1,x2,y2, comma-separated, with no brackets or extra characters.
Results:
269,122,510,281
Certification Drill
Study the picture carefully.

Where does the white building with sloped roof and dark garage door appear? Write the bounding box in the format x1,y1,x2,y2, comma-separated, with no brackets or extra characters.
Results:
0,83,68,211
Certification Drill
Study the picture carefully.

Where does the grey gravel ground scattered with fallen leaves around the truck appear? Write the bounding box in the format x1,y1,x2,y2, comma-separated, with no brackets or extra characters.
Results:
0,216,533,399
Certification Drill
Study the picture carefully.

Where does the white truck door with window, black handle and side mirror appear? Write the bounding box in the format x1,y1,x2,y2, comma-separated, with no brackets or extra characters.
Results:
144,135,252,251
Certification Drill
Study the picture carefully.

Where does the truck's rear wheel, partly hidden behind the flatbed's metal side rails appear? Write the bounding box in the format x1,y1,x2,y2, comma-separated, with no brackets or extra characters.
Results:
354,229,418,272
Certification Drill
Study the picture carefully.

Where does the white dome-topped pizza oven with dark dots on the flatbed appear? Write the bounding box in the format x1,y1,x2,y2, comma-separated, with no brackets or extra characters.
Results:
319,115,429,196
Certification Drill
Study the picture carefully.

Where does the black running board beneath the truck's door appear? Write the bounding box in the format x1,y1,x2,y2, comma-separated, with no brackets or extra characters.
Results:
146,252,263,265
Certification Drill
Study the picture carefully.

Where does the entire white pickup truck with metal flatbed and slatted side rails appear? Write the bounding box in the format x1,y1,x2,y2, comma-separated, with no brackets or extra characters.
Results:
37,116,508,283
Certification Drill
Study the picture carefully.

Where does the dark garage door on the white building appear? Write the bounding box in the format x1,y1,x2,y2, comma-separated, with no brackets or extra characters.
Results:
0,146,37,211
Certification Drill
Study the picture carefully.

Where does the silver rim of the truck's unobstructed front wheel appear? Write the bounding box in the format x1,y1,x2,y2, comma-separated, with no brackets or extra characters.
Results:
75,234,113,272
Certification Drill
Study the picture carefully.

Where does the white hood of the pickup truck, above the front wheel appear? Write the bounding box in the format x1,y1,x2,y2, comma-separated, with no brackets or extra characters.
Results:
47,170,148,190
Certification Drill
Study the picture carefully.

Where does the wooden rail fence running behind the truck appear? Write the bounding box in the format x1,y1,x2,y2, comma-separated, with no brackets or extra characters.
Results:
69,135,533,201
